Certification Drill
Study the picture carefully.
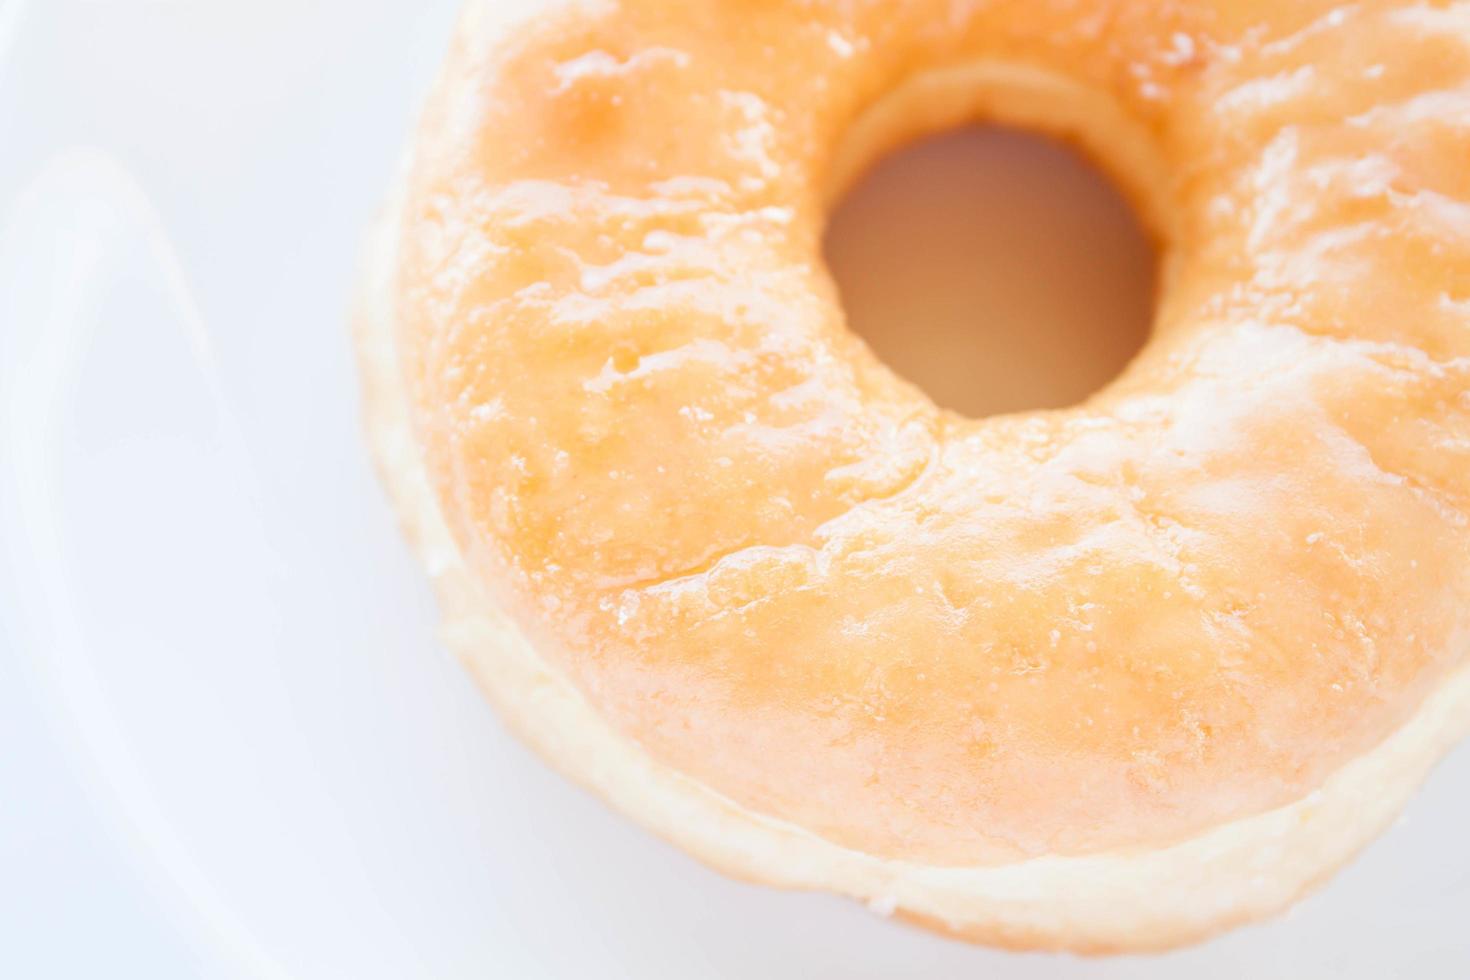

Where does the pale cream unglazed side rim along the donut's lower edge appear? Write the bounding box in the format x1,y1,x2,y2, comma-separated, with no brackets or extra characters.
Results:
351,159,1470,954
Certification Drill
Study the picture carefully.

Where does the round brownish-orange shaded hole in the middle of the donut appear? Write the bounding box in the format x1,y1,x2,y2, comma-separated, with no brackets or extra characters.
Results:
823,126,1157,417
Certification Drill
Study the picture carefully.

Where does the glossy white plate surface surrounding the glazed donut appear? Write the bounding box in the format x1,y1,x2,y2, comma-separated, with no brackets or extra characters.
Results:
0,0,1470,980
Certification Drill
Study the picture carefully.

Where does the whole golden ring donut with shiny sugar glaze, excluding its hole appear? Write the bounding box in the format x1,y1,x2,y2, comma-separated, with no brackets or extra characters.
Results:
357,0,1470,951
